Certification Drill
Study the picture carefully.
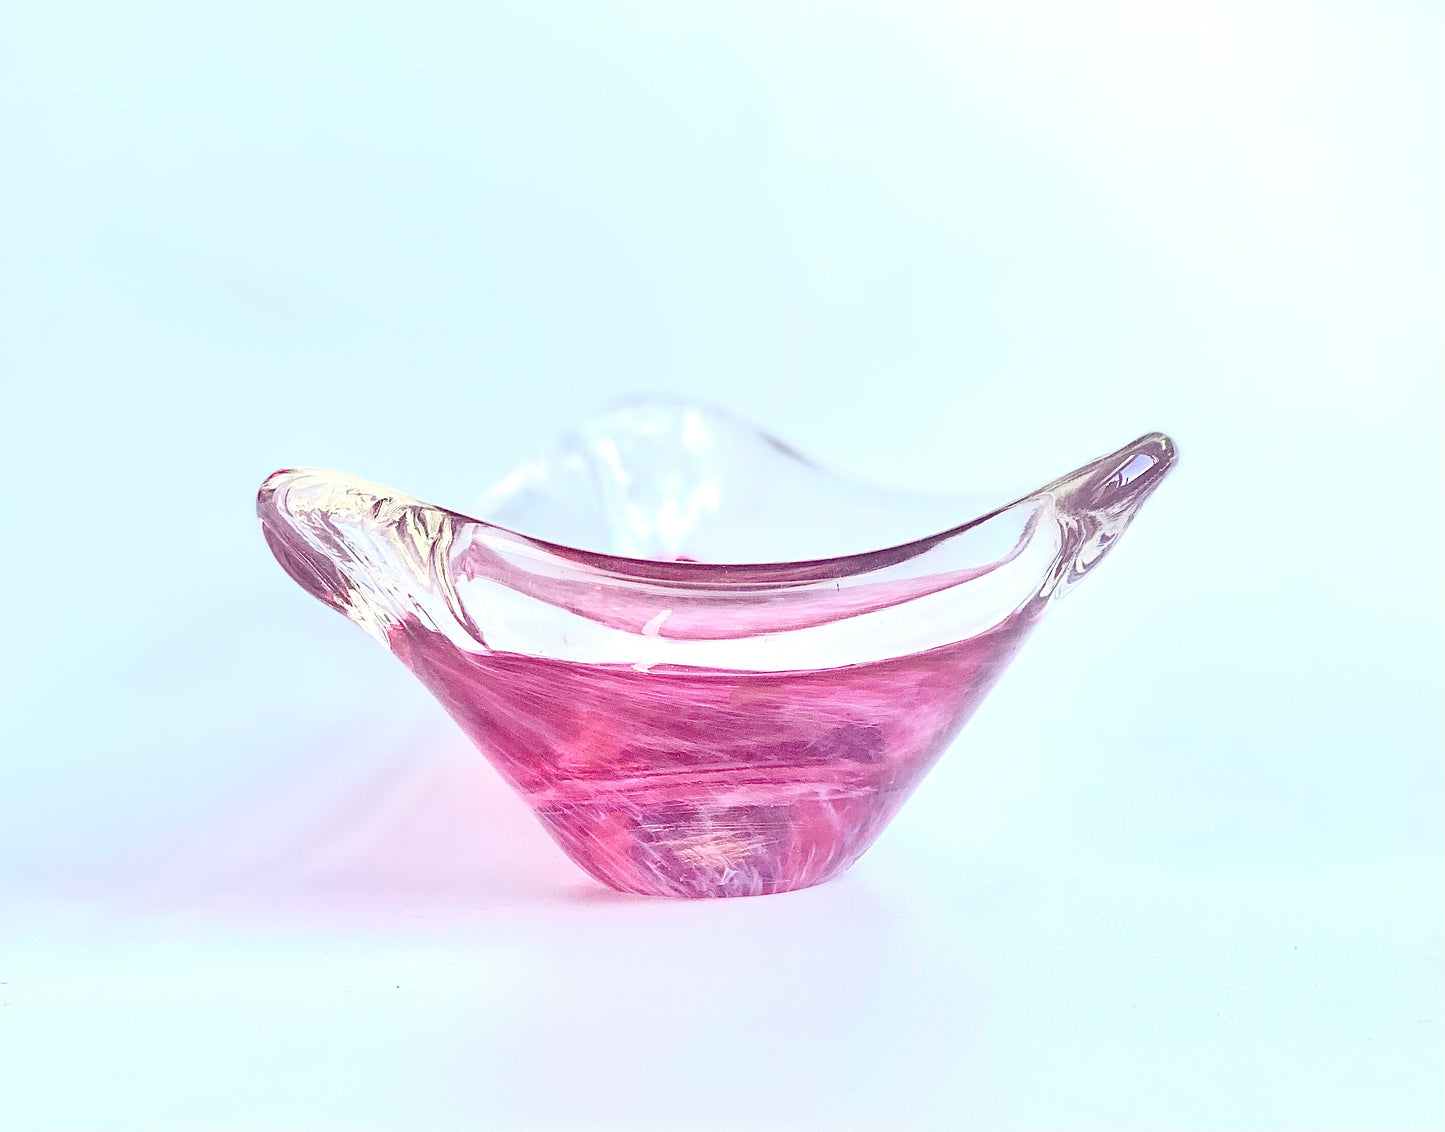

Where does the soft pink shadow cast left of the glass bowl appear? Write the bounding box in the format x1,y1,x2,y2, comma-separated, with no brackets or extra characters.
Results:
118,720,621,918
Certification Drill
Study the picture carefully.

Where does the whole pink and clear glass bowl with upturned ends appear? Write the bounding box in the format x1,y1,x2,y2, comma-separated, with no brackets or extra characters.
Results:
257,403,1175,896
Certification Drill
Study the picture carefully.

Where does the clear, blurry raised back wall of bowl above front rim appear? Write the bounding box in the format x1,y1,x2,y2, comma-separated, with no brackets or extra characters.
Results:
473,402,1006,564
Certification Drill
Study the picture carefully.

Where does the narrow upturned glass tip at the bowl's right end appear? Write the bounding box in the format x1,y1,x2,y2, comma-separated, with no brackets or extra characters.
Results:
1033,432,1176,597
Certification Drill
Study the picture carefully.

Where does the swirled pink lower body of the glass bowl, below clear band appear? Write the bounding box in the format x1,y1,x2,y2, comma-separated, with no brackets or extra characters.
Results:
392,616,1030,896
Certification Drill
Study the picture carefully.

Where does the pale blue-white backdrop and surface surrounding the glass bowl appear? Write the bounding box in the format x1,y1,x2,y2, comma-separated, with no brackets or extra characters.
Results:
0,0,1445,1129
